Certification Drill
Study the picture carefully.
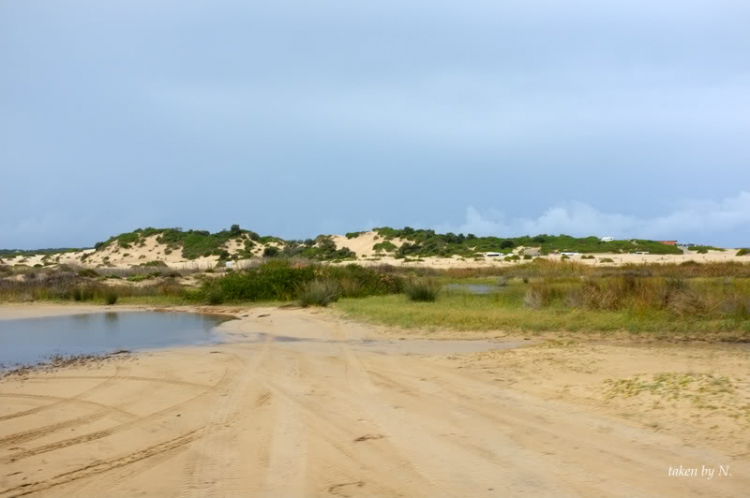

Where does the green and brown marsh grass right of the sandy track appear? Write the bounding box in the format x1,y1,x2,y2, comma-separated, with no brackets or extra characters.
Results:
336,277,750,334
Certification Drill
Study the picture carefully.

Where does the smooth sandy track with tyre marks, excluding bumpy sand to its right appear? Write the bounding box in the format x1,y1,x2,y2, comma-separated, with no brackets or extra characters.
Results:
0,310,750,498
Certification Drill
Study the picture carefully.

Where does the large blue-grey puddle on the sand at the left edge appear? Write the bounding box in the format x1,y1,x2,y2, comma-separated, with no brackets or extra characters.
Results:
0,311,226,367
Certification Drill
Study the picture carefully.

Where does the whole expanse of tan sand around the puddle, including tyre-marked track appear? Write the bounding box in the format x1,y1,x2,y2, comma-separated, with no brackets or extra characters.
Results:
0,305,750,497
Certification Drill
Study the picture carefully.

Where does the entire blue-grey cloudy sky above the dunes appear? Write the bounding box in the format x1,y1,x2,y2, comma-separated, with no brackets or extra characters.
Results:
0,0,750,249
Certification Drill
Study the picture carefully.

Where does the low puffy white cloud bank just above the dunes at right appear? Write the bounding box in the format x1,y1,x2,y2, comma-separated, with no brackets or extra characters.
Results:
446,191,750,245
